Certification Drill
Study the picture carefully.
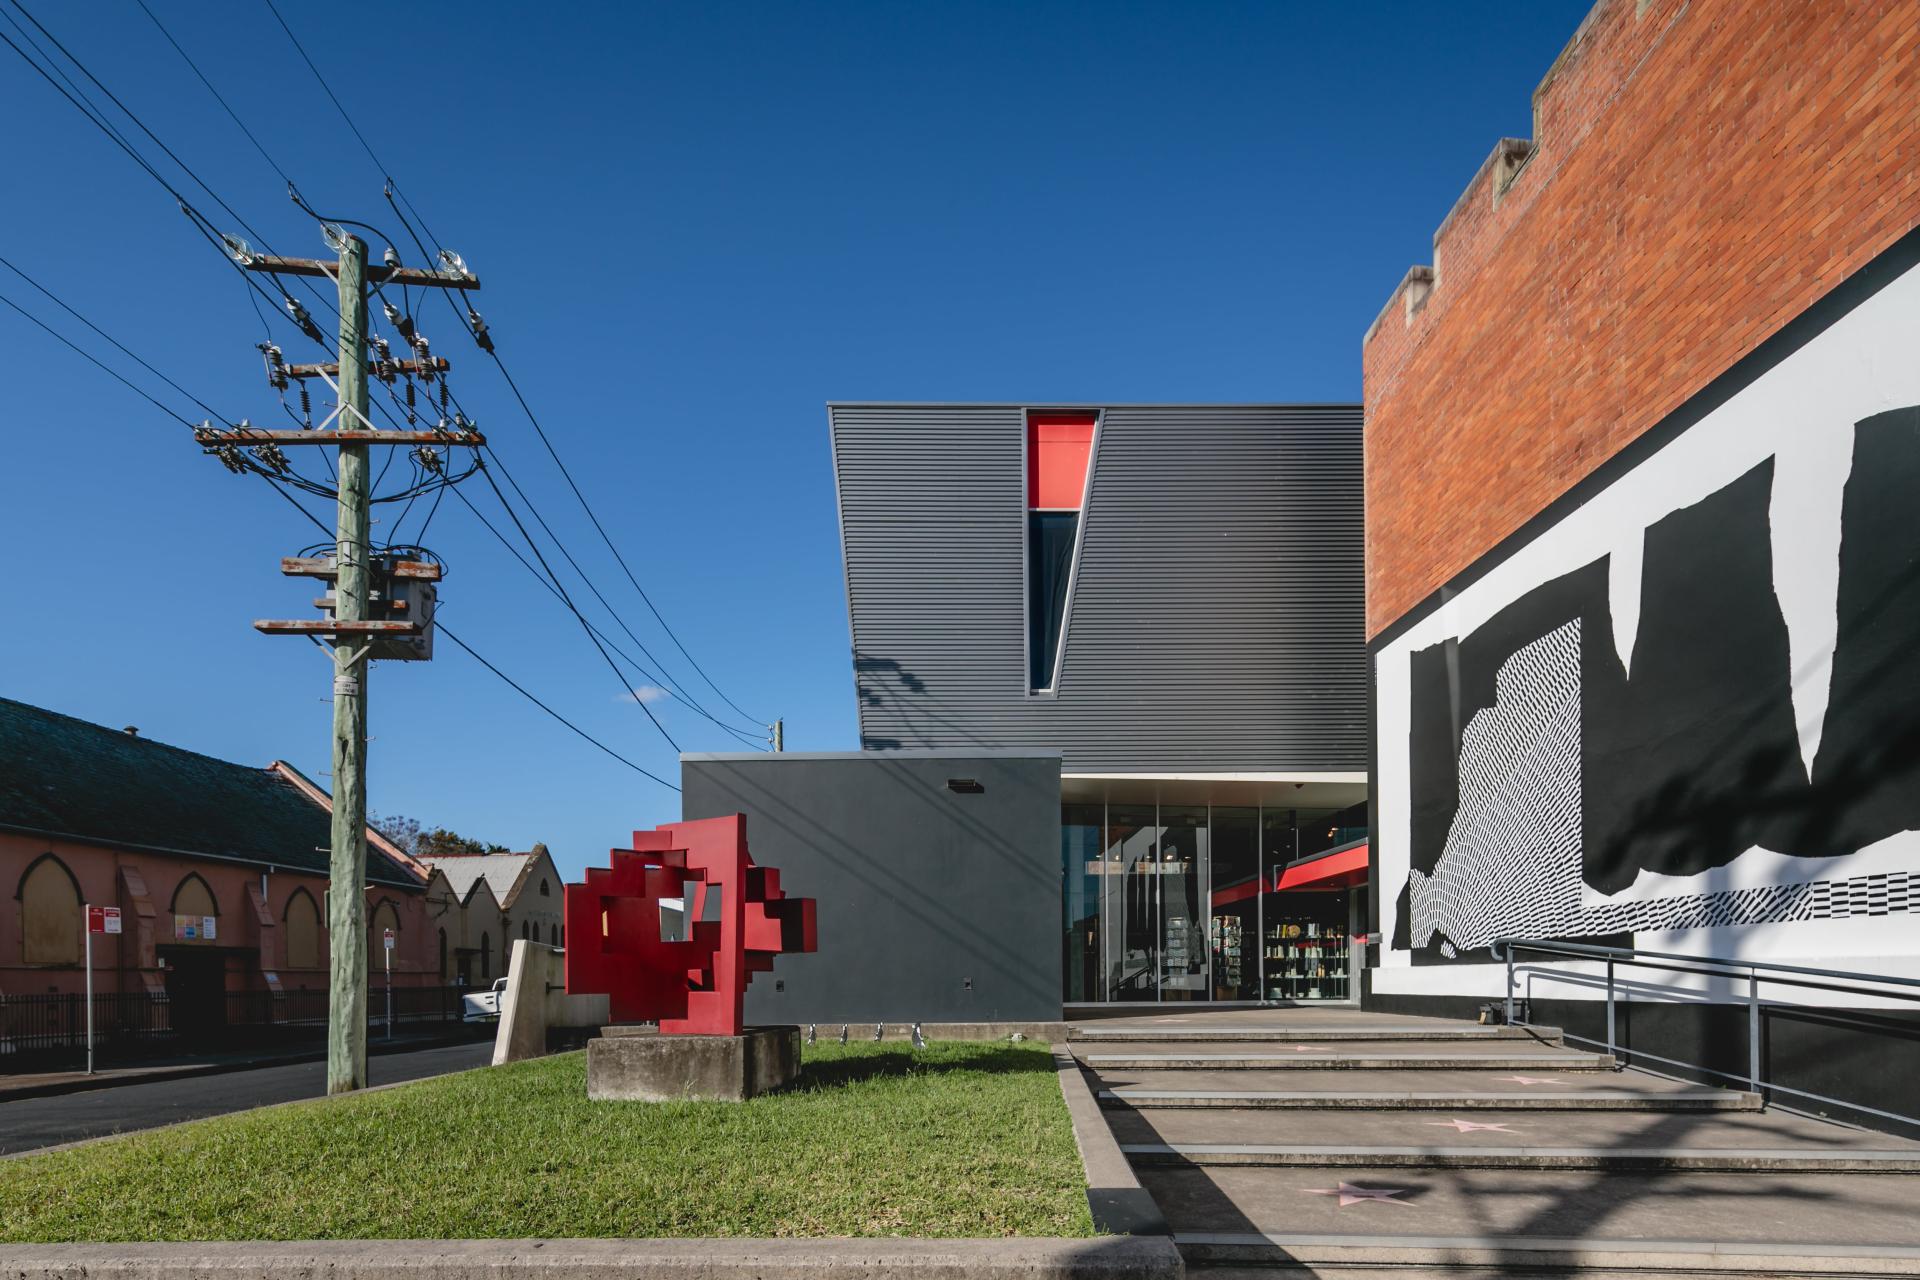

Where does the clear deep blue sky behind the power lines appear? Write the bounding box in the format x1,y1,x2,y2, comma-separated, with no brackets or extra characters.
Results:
0,0,1586,873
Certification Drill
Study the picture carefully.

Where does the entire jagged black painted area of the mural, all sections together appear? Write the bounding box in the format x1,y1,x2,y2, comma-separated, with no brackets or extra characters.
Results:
1392,407,1920,963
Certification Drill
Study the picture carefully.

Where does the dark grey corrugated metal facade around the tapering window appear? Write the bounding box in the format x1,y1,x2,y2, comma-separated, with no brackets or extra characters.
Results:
829,403,1367,773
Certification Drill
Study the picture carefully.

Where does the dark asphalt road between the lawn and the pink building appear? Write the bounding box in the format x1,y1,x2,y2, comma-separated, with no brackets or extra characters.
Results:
0,1040,493,1155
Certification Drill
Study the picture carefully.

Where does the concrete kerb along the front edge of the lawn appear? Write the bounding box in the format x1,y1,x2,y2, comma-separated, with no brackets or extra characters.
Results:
0,1236,1183,1280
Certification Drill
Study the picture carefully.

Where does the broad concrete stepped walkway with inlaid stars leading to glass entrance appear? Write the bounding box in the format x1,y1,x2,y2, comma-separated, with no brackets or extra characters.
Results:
1069,1009,1920,1280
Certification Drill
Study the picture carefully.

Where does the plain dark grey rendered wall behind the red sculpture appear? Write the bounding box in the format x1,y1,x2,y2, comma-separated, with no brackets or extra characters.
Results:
680,752,1062,1023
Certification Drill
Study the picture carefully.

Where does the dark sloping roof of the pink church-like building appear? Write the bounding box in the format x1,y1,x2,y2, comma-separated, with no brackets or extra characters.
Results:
0,699,422,889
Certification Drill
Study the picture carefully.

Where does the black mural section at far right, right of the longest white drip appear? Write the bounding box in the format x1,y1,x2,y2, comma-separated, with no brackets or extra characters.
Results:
1788,407,1920,854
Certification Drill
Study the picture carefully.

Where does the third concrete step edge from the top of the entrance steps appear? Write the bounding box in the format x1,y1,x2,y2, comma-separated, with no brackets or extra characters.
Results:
1098,1084,1761,1111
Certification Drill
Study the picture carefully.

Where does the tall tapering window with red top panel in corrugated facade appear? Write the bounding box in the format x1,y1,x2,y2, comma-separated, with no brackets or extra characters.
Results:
1027,413,1094,689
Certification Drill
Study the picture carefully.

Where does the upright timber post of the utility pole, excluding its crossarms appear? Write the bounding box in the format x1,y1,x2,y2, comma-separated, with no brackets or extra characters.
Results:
326,236,372,1094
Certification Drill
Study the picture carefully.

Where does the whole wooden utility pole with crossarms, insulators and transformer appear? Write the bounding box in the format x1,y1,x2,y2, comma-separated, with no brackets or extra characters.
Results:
194,226,486,1094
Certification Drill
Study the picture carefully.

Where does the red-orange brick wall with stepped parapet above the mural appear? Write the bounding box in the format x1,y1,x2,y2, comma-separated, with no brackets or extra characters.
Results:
1363,0,1920,635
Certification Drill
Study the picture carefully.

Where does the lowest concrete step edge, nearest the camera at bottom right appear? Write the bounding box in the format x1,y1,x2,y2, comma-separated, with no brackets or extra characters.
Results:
1173,1232,1920,1280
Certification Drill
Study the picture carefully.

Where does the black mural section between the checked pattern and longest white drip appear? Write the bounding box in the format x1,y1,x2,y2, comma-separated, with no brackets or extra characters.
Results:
1580,459,1807,894
